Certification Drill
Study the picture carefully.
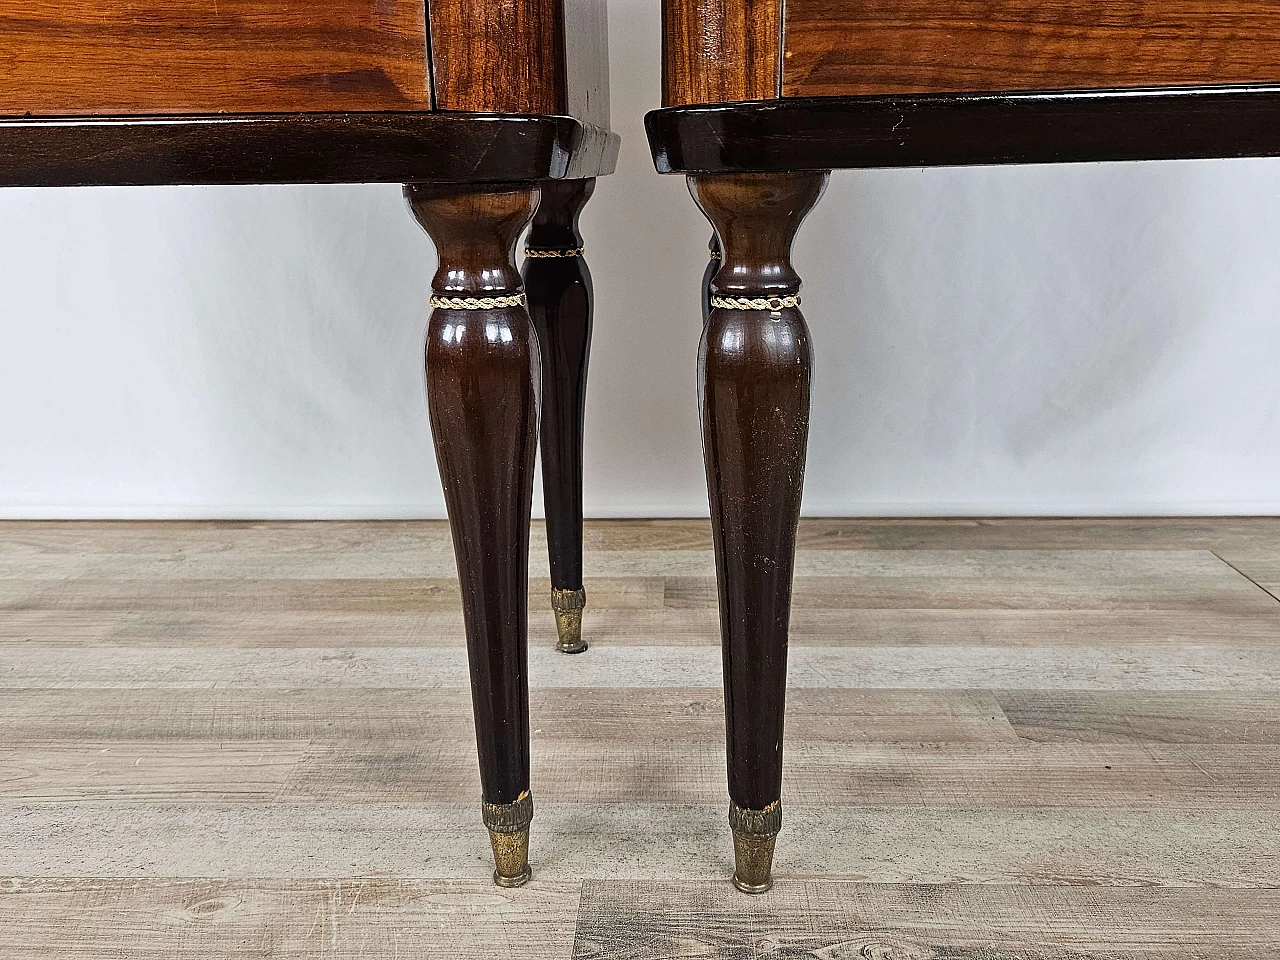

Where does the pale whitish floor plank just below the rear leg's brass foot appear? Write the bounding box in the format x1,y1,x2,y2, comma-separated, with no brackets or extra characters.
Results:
0,644,1280,690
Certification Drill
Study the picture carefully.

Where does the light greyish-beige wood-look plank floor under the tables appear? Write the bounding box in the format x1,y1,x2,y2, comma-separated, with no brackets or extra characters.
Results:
0,520,1280,960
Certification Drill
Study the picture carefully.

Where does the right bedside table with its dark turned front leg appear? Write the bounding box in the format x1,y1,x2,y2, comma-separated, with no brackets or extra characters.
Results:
646,0,1280,892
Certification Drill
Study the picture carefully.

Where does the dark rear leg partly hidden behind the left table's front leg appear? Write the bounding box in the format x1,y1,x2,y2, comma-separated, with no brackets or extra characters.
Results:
525,179,595,653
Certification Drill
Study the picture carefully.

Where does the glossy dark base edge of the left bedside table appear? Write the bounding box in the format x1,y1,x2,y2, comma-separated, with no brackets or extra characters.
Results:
0,113,620,187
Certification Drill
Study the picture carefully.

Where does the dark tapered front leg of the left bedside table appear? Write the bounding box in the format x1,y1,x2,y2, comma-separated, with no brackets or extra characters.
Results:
404,184,539,887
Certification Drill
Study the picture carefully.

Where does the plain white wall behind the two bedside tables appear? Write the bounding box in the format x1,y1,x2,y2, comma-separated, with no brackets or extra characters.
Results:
0,0,1280,517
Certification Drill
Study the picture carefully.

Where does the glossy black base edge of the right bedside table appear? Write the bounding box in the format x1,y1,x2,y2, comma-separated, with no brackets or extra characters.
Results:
645,84,1280,173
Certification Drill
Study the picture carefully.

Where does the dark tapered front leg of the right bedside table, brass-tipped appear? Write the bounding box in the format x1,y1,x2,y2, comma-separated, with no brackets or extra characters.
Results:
689,173,827,893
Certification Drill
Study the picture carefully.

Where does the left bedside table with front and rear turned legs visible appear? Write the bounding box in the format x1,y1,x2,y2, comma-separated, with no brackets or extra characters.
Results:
0,0,618,886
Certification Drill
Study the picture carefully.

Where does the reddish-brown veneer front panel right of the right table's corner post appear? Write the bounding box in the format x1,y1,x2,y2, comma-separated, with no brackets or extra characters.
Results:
782,0,1280,97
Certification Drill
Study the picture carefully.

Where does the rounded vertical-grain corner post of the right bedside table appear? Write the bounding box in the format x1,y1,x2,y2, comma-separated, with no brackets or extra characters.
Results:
662,0,783,106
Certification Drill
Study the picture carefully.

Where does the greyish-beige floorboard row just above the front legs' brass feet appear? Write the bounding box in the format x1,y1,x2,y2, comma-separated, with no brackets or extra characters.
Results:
0,737,1280,812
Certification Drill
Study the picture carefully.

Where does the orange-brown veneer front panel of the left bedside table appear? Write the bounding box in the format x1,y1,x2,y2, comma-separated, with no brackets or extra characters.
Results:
0,0,430,116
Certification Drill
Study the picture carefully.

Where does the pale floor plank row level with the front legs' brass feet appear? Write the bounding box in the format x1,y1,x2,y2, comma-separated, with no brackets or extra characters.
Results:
0,792,1280,897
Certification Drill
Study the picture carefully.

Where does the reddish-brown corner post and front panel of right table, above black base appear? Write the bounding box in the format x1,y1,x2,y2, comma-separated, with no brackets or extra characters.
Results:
663,0,1280,106
